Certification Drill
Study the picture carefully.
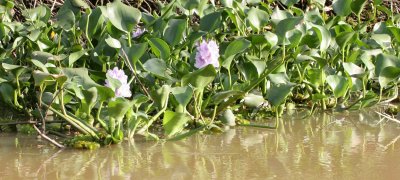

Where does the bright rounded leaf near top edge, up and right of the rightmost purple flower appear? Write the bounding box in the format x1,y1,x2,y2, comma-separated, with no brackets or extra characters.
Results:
247,7,269,31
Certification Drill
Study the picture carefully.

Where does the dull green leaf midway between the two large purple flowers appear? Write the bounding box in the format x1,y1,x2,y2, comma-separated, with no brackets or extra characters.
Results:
143,58,169,79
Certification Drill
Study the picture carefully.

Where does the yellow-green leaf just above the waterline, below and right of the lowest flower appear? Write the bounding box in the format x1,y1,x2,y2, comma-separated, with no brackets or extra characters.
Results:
163,111,190,137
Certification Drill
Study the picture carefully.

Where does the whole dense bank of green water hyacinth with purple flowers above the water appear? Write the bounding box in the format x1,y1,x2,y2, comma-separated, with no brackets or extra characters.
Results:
0,0,400,148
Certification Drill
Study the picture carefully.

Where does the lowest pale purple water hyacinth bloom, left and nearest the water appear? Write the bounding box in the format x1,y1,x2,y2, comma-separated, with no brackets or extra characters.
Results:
105,67,132,97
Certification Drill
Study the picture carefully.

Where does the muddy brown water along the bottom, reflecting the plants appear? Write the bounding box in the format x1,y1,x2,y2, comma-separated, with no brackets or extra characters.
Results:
0,110,400,179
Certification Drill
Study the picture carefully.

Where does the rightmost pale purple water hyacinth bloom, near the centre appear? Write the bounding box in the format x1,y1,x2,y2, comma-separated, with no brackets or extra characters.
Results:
194,40,219,69
